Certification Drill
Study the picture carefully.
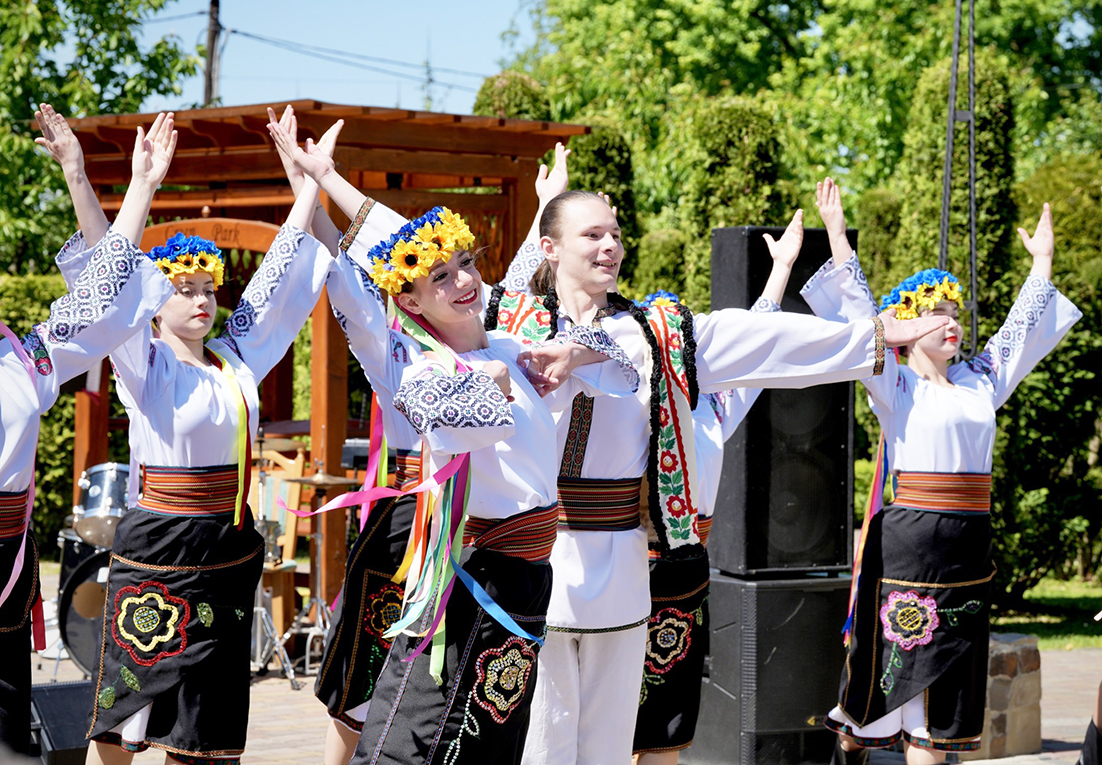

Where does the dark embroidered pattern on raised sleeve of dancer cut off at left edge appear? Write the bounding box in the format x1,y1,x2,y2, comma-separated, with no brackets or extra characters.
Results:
45,231,144,344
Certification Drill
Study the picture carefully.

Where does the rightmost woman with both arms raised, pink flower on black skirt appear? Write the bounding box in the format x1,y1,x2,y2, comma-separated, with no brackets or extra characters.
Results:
802,179,1082,765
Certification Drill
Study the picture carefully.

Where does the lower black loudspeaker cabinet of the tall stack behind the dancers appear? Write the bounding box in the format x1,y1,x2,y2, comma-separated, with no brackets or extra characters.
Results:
681,571,850,765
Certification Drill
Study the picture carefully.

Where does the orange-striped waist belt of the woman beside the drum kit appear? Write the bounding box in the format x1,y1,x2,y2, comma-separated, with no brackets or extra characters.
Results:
138,465,237,517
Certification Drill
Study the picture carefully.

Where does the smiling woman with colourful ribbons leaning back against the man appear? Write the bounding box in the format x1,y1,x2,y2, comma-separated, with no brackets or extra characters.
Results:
269,115,637,763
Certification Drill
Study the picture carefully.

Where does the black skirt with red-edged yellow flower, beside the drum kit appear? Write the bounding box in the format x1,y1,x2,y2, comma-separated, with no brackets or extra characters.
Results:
88,508,263,763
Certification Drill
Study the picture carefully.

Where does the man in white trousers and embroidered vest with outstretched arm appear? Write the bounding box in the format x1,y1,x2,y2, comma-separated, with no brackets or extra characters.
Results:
486,191,946,765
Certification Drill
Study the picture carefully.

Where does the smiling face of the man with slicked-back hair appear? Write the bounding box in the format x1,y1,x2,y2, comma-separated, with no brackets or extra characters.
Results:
540,197,624,295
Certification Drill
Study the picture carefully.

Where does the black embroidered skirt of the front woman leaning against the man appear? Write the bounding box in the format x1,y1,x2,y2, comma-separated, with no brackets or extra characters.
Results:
352,547,551,765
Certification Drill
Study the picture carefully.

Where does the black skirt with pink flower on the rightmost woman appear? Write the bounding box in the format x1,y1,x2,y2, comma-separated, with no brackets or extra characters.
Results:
828,506,994,751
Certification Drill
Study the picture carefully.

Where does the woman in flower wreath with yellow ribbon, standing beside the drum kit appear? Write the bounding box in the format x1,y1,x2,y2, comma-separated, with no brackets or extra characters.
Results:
81,123,339,765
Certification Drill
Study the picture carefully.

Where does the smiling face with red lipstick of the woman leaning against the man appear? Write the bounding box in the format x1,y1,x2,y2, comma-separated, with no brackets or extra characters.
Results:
395,250,483,327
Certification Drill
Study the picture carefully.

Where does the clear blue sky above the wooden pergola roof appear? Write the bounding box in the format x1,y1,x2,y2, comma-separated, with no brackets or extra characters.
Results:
143,0,534,114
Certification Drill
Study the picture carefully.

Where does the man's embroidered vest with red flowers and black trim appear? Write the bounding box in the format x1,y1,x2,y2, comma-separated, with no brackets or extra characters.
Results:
486,290,703,559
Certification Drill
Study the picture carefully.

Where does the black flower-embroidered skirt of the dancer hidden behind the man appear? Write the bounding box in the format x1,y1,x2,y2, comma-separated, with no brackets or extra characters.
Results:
631,552,711,754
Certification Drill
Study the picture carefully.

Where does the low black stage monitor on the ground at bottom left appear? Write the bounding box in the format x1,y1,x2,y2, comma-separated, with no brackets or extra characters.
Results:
31,680,96,765
